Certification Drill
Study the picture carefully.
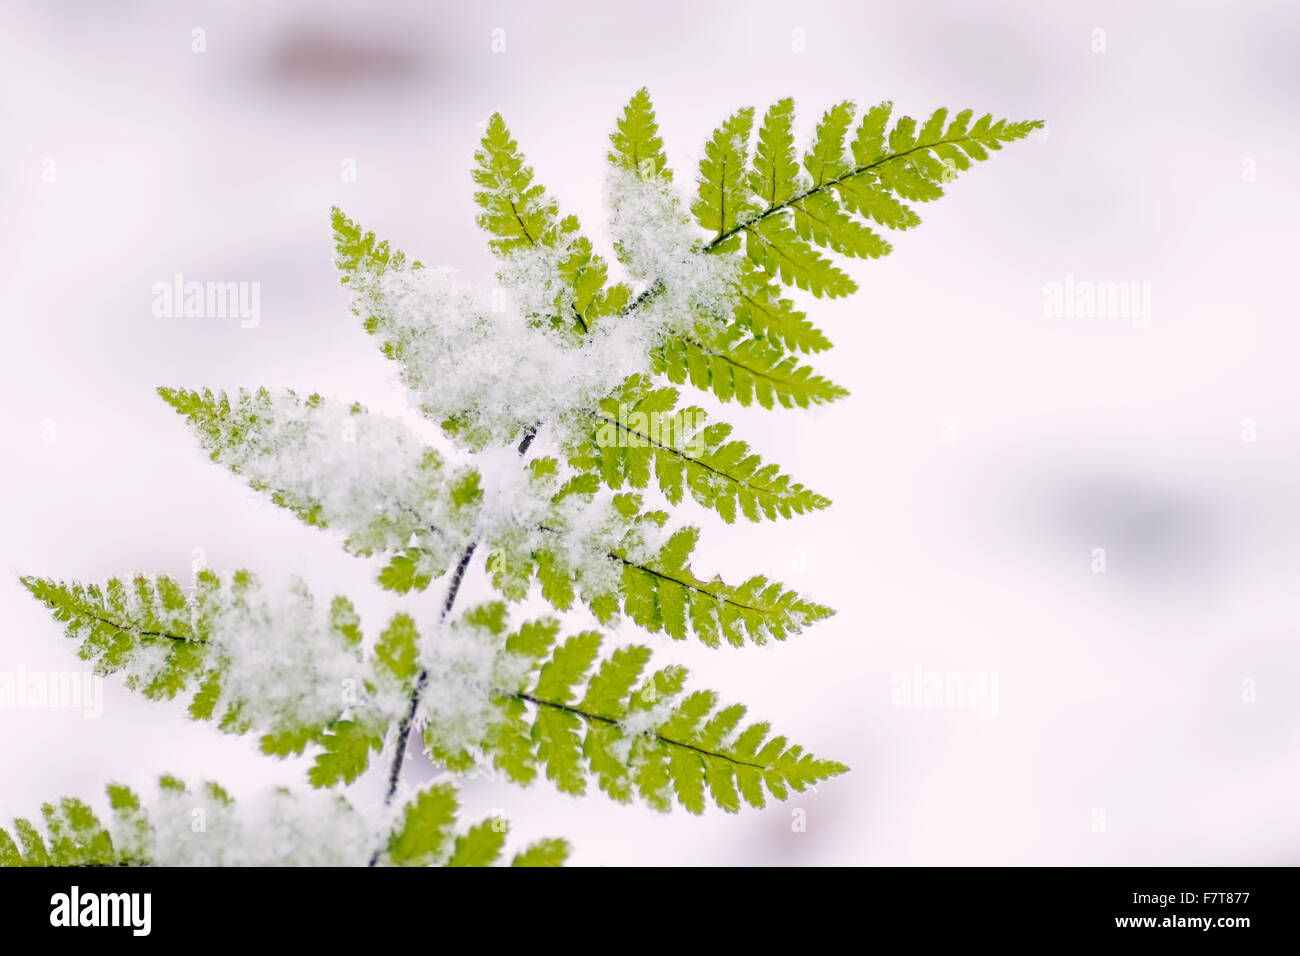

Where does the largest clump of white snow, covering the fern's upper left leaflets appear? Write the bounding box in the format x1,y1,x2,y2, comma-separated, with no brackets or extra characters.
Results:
350,169,733,449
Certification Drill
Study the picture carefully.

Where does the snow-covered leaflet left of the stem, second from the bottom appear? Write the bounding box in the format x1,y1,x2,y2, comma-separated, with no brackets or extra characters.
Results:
22,571,417,787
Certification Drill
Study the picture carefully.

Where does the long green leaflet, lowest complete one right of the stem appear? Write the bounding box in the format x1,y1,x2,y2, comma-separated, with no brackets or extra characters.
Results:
420,605,846,811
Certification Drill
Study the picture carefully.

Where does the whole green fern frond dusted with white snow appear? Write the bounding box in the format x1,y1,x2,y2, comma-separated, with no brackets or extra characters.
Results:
0,90,1039,865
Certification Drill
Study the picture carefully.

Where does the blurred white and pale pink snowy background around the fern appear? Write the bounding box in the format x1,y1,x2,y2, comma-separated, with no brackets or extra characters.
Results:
0,0,1300,865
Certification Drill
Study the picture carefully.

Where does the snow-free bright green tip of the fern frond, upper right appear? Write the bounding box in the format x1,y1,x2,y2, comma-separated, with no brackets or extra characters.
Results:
654,99,1041,418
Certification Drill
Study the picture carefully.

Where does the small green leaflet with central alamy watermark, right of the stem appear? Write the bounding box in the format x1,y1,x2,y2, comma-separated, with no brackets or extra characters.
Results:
569,376,831,524
